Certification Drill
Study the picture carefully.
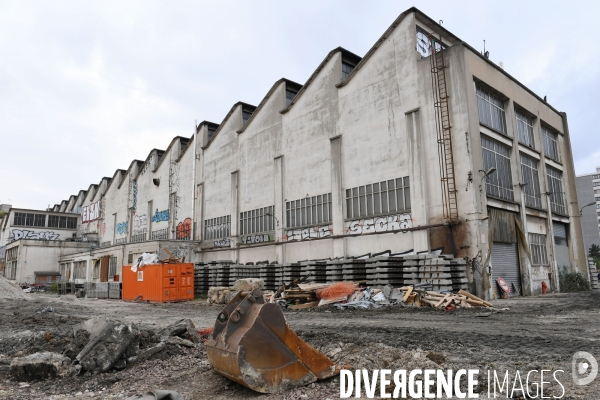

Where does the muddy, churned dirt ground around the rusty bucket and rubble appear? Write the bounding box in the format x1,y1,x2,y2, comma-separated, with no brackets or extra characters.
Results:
0,291,600,400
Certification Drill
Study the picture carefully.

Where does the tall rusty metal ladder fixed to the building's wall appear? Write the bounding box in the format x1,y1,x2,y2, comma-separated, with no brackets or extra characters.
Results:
429,35,458,222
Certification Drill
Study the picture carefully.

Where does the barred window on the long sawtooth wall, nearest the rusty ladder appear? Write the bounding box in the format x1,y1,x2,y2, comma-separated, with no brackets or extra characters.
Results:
346,176,410,218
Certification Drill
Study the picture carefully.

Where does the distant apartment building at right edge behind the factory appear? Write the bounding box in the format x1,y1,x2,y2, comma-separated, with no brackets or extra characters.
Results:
576,167,600,252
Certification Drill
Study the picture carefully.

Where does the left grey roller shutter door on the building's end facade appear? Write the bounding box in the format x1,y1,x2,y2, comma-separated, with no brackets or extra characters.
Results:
492,242,521,298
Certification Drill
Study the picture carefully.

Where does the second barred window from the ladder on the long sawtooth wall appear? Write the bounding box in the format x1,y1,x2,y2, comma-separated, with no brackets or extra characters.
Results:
285,193,331,228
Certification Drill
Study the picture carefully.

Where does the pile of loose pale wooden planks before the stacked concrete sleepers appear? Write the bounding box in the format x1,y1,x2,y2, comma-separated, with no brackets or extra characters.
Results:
400,286,494,309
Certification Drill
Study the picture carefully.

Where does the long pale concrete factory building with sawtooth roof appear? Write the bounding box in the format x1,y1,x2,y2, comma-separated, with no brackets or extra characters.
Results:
0,8,588,298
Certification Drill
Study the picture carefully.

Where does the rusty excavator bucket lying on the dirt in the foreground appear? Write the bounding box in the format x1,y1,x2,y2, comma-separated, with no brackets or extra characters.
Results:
207,289,340,393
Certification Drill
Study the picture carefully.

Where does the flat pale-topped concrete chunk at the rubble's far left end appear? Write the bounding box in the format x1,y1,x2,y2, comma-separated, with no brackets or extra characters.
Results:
10,351,77,382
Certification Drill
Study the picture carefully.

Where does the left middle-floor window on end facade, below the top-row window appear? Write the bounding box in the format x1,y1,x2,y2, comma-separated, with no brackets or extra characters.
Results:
481,136,514,201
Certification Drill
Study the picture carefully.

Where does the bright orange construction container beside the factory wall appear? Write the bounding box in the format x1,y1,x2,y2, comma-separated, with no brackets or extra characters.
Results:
122,263,194,303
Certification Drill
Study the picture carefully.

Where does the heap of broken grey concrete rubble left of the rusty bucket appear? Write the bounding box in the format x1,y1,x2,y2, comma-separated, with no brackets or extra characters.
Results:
5,317,202,382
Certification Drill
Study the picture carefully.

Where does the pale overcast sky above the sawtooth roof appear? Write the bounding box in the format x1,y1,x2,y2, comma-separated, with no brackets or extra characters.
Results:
0,0,600,209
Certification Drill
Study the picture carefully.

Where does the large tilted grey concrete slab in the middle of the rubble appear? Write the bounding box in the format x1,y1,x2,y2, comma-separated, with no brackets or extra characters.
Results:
77,321,140,373
